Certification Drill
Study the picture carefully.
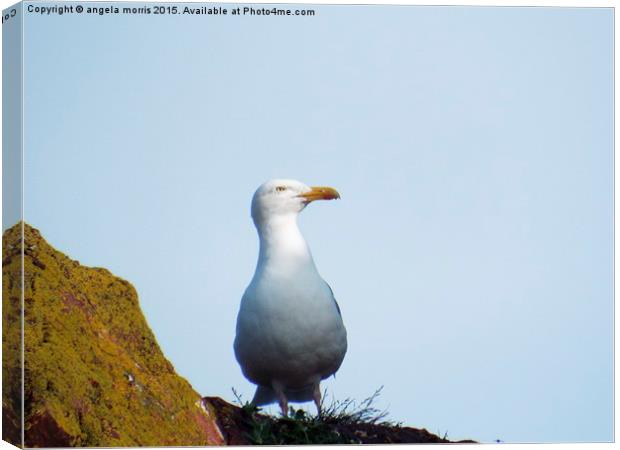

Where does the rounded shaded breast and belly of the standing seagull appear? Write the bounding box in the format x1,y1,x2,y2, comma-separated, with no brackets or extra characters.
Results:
235,258,347,389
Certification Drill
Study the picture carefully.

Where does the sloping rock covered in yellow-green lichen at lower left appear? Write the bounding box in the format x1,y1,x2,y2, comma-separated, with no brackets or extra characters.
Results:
2,224,221,446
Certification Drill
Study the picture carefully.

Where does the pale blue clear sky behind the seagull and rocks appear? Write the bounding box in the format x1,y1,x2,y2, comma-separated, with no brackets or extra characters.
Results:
10,3,613,442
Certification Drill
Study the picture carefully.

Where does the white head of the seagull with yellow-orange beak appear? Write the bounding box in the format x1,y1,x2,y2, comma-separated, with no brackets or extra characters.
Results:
252,179,340,225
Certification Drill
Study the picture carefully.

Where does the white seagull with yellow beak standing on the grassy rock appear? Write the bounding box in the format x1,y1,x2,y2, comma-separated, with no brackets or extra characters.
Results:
234,179,347,416
